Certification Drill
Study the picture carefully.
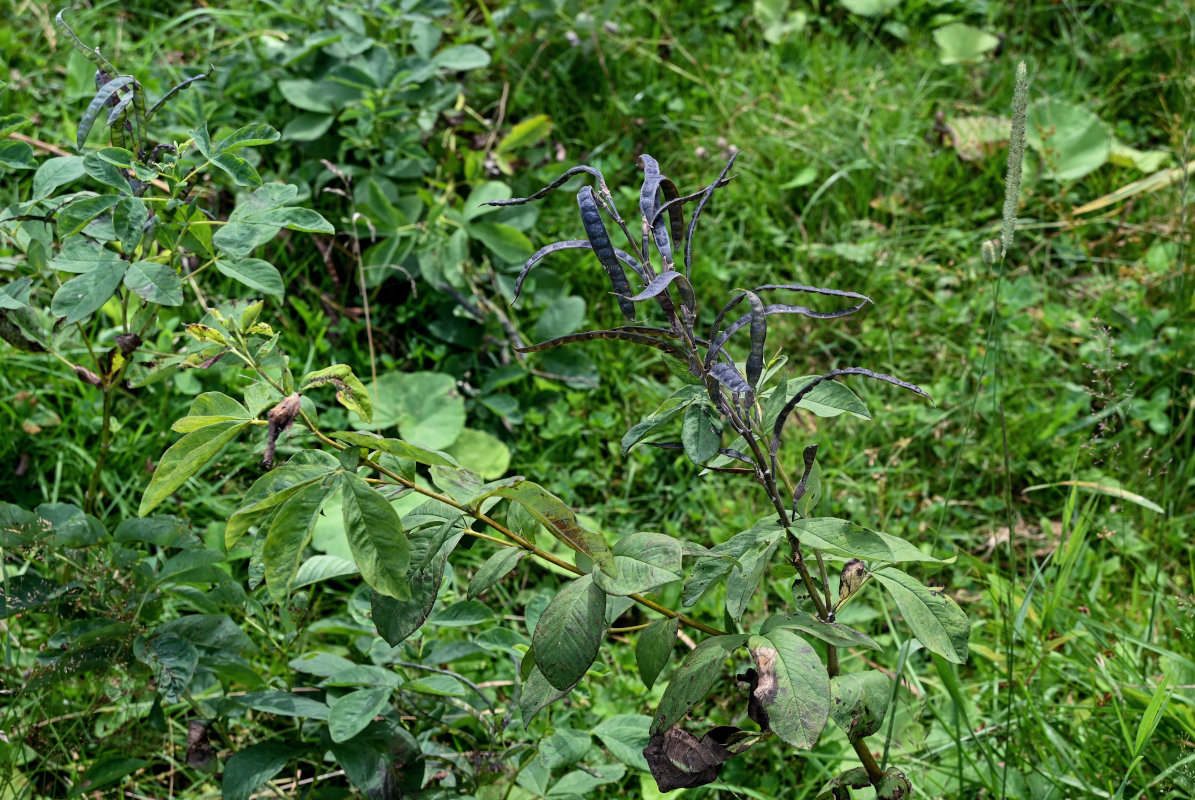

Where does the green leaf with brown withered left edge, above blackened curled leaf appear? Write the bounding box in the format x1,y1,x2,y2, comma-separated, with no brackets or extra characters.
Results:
747,628,829,750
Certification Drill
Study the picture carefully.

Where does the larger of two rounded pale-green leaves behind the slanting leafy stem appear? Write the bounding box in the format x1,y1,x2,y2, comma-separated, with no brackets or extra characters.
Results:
369,372,465,450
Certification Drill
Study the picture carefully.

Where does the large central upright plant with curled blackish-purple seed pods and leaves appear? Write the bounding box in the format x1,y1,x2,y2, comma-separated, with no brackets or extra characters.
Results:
478,154,969,798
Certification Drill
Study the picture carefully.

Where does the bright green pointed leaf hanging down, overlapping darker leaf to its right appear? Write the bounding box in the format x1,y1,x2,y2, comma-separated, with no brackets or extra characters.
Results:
342,472,411,600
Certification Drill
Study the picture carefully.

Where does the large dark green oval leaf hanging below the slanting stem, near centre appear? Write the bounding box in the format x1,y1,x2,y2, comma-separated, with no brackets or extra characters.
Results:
532,575,606,690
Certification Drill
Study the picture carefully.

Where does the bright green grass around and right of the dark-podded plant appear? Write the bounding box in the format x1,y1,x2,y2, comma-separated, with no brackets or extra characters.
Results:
0,2,1195,798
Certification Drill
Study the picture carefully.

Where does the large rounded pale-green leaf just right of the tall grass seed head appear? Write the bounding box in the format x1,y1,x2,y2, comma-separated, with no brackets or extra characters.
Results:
1025,97,1113,181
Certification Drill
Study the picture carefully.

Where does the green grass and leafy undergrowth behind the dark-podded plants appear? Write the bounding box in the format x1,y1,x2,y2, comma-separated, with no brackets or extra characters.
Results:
0,0,1195,798
